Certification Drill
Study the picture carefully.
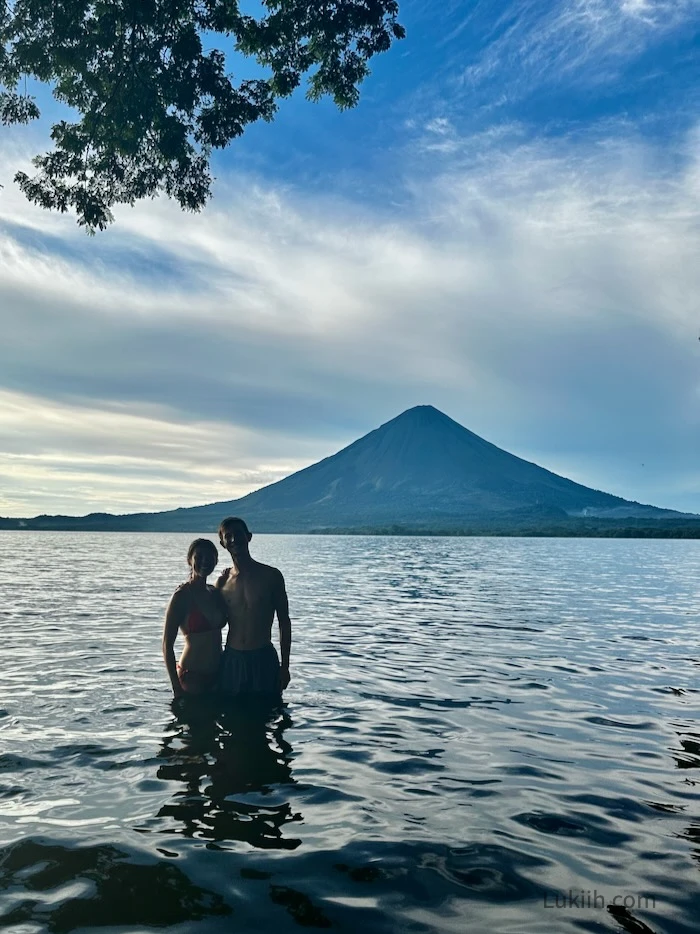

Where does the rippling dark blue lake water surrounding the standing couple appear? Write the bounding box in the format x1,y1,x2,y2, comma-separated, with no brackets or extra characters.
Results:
0,532,700,934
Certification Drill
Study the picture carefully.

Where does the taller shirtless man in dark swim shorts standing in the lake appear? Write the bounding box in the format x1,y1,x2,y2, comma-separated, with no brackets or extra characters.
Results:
216,516,292,696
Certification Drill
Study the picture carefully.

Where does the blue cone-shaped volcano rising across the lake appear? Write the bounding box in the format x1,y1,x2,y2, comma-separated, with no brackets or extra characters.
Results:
6,405,683,532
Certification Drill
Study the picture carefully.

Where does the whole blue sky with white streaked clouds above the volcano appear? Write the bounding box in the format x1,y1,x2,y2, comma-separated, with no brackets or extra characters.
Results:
0,0,700,517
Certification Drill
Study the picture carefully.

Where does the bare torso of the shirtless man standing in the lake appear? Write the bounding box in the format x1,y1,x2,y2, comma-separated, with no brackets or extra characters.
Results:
217,561,282,651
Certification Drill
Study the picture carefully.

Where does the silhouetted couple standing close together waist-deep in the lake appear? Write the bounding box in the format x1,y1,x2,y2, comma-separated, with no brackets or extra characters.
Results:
163,517,292,698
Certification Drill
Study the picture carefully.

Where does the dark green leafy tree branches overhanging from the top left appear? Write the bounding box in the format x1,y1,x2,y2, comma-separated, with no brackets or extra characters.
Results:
0,0,404,233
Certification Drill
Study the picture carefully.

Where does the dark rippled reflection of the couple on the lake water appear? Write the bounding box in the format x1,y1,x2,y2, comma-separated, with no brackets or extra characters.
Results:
148,698,302,850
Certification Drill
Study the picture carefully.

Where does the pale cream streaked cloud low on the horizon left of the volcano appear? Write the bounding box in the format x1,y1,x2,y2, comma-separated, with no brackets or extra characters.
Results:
0,391,326,516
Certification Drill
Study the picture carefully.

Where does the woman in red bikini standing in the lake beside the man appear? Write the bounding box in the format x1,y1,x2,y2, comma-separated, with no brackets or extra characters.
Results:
163,538,226,697
